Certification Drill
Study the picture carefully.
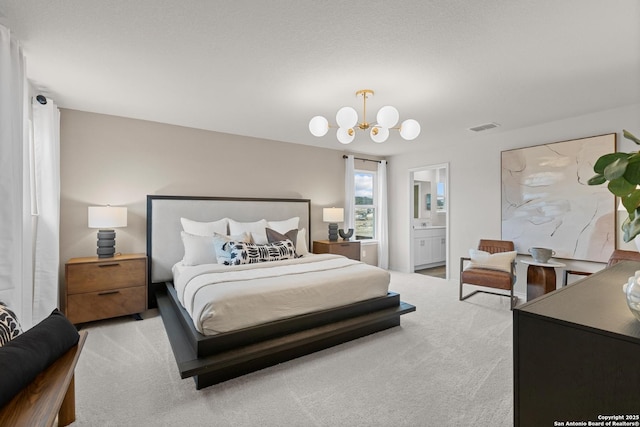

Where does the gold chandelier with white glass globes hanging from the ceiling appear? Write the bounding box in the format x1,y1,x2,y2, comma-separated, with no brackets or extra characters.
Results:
309,89,420,144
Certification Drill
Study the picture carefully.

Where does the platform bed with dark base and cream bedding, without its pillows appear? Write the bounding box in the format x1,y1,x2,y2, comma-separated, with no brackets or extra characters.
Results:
147,195,415,389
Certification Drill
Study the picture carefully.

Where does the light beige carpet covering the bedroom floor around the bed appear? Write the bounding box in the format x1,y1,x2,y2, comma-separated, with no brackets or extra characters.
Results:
73,272,513,427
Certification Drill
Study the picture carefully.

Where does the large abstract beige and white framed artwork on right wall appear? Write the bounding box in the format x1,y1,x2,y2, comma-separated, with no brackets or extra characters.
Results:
501,133,617,262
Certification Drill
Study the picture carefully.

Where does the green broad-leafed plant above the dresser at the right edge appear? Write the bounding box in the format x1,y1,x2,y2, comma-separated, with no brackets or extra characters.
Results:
588,130,640,242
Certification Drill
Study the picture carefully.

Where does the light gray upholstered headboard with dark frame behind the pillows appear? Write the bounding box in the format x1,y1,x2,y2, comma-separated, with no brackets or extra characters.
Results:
147,195,311,290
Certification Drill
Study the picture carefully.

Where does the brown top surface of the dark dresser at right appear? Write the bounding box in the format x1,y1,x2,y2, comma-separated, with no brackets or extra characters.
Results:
514,261,640,341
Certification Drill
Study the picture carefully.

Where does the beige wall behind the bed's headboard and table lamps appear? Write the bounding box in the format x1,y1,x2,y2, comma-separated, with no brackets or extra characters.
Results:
60,109,375,280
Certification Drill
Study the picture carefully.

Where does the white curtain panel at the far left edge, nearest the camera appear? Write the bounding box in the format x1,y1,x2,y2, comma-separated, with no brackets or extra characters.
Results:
0,25,32,328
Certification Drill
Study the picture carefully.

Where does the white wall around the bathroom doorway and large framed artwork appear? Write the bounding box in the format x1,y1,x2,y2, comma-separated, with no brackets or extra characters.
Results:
389,104,640,296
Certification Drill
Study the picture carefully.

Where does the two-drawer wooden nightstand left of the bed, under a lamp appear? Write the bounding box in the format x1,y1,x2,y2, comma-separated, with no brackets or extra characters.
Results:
65,254,147,324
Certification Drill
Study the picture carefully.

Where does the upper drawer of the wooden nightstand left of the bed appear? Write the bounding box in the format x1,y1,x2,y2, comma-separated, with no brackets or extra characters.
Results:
66,258,147,294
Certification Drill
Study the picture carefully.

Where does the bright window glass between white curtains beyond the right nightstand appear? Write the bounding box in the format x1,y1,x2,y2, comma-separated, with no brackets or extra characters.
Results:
354,170,377,240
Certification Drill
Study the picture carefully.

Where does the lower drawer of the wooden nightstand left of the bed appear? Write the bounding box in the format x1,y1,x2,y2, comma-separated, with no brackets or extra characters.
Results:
67,286,147,323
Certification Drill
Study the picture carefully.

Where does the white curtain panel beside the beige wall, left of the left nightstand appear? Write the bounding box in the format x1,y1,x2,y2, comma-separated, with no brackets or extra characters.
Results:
31,99,60,324
